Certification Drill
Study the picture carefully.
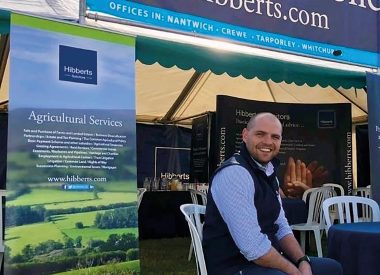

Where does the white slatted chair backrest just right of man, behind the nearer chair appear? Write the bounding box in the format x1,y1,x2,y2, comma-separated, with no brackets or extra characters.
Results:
302,187,331,228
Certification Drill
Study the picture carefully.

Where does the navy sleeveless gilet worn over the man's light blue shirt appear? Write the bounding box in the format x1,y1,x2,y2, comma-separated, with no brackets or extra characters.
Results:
203,142,281,275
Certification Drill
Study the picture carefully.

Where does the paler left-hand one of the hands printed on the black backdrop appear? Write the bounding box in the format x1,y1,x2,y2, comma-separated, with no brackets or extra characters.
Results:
282,157,313,198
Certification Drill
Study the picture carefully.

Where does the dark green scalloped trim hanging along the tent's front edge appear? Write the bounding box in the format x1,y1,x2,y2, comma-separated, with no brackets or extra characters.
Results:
136,36,366,89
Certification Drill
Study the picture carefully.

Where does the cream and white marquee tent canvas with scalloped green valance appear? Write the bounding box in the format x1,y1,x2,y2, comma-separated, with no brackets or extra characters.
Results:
0,0,372,124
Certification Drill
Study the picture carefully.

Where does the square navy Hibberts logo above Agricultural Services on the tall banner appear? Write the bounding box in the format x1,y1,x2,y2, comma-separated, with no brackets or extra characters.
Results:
59,45,98,85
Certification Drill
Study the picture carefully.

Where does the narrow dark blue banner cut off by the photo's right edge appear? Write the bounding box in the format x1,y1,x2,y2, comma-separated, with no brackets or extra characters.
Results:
367,73,380,203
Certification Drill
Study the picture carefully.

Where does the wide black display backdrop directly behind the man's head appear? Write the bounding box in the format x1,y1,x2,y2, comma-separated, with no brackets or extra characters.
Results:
215,95,353,196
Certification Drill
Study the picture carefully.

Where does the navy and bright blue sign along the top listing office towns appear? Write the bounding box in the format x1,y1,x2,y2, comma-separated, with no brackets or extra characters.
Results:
87,0,380,67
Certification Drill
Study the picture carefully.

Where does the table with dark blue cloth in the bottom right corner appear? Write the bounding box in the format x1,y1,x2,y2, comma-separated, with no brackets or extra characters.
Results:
328,222,380,275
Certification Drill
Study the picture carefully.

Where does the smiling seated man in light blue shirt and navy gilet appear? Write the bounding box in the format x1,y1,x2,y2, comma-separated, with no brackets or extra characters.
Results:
203,113,342,275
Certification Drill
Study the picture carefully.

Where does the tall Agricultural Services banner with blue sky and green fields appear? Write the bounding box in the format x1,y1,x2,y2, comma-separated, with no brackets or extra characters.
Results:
5,14,139,274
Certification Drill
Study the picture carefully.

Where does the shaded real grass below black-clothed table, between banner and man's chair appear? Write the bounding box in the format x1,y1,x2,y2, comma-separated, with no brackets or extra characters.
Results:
140,237,197,275
